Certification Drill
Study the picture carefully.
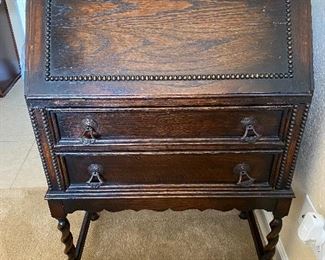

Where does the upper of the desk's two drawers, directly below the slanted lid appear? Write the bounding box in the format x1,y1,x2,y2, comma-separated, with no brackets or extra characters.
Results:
51,106,288,144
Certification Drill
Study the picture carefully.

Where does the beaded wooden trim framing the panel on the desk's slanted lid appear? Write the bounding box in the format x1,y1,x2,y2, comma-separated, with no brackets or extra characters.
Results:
45,0,293,81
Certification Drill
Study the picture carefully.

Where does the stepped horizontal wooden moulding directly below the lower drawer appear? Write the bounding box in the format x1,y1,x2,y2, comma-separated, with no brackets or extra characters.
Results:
46,184,293,199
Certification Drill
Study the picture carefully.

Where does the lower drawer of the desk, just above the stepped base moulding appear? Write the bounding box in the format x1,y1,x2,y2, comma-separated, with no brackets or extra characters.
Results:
61,152,278,188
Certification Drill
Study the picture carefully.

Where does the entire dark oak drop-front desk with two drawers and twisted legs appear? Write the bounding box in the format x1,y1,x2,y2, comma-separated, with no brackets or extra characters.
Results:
26,0,313,259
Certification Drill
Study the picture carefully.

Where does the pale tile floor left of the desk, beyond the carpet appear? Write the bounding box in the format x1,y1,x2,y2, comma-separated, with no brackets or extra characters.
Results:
0,80,46,189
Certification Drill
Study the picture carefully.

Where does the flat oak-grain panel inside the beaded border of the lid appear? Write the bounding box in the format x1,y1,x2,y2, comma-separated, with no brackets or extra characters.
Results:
51,0,287,76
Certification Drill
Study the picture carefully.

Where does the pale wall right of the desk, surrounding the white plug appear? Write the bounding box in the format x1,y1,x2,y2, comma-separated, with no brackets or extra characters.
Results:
281,0,325,260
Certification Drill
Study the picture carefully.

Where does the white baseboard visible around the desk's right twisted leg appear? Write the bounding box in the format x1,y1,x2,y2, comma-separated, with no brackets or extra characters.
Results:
255,210,289,260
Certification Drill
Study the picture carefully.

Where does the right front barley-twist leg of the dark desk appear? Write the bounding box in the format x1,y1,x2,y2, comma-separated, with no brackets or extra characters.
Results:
262,218,282,260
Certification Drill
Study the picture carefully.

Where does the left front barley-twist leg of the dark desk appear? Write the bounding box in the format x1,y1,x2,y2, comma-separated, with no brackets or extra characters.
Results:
58,218,76,260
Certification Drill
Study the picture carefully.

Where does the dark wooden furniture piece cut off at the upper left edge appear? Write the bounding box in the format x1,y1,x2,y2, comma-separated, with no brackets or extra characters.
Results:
0,0,21,97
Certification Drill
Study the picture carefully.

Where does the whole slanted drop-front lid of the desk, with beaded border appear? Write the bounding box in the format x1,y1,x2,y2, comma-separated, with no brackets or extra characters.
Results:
26,0,312,97
